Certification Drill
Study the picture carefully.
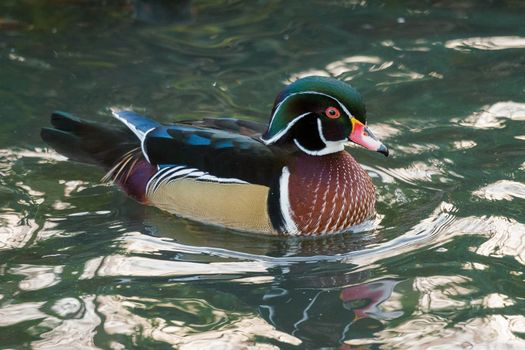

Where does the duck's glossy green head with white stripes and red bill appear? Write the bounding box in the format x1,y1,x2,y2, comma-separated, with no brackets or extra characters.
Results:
261,76,388,156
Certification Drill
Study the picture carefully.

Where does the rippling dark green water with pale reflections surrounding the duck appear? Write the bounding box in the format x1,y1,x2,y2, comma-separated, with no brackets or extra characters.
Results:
0,0,525,349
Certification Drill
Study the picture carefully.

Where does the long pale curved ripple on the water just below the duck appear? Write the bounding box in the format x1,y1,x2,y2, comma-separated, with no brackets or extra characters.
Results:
69,203,456,279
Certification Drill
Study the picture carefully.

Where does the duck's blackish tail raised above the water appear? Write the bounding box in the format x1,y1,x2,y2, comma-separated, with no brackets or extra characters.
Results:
41,112,140,169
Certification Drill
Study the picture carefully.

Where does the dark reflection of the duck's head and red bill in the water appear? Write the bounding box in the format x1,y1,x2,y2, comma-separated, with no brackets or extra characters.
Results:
259,271,403,348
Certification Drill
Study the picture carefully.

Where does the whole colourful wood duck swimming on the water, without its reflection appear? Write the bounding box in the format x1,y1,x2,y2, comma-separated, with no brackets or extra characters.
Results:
41,76,388,236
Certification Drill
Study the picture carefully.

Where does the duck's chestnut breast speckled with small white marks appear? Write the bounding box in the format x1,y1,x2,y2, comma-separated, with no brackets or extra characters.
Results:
288,151,375,235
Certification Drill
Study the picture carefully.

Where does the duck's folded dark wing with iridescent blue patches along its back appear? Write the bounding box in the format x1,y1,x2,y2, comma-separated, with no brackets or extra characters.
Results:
113,111,287,187
